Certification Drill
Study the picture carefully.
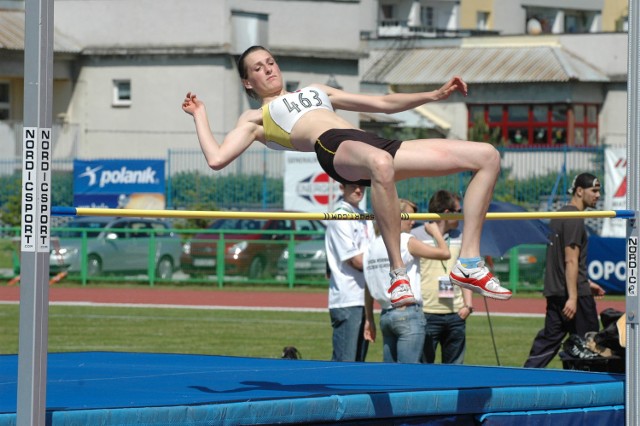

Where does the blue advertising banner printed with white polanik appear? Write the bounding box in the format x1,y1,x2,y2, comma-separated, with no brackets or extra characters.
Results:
73,160,165,210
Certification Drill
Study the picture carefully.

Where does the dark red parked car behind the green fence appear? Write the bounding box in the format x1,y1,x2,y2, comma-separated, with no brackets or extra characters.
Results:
180,219,325,279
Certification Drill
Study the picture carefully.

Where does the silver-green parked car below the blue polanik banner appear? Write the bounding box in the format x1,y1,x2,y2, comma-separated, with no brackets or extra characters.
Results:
49,217,182,279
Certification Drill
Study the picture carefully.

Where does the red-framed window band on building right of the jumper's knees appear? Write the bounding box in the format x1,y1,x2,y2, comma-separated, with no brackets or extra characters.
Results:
468,104,598,146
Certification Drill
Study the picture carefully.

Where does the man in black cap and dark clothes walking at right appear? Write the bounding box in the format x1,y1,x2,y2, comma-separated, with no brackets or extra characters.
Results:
524,173,604,368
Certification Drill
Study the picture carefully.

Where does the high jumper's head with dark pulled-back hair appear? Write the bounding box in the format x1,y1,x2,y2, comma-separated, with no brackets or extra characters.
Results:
242,50,282,98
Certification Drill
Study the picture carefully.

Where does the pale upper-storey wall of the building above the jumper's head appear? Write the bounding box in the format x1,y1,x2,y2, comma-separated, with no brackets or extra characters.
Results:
55,0,362,51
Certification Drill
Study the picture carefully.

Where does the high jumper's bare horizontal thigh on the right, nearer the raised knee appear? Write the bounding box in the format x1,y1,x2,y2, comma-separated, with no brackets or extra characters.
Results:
394,139,495,179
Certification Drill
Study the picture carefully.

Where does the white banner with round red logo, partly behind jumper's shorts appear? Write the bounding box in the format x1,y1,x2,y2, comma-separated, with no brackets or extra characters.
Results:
284,151,366,213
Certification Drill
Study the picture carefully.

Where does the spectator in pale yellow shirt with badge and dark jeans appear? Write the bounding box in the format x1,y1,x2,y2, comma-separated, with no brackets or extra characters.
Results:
412,190,473,364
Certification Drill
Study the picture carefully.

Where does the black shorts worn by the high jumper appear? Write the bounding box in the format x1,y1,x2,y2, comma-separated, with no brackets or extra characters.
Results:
314,129,402,186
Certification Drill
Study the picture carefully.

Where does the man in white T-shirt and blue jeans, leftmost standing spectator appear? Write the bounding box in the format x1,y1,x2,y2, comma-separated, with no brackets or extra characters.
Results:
325,183,376,361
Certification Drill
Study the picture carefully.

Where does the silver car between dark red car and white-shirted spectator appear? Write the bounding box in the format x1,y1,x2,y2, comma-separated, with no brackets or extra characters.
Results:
278,235,327,276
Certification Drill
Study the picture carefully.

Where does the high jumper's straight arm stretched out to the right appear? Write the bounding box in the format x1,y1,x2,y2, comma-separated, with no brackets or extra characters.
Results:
318,76,467,114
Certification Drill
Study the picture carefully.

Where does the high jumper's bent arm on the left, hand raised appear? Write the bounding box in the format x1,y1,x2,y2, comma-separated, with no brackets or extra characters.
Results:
182,92,258,170
